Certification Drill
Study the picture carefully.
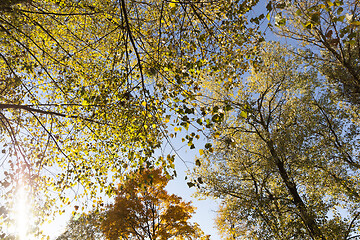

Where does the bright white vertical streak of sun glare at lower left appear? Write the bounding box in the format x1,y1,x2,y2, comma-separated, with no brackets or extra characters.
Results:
14,181,30,240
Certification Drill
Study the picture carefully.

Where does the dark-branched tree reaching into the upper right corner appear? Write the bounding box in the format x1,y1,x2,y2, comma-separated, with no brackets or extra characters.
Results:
268,0,360,105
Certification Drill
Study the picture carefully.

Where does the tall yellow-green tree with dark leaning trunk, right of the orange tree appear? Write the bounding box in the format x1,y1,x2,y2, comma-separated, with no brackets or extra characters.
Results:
194,44,360,240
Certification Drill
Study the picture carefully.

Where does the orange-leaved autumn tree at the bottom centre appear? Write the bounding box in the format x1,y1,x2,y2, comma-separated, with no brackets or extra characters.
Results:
101,169,209,240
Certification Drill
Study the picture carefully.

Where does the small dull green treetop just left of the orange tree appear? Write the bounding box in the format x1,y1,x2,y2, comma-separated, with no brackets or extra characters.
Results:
56,212,104,240
